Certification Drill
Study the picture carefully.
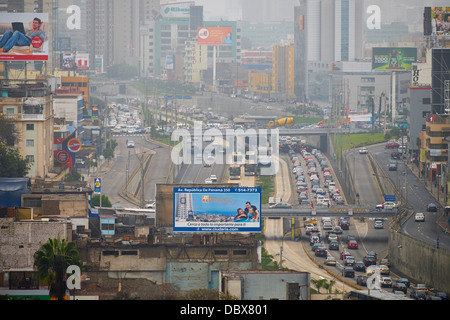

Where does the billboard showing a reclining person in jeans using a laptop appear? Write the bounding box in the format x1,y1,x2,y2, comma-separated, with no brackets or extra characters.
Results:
0,12,50,61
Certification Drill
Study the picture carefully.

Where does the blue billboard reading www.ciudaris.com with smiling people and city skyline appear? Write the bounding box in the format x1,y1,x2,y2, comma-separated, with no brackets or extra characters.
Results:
173,187,261,232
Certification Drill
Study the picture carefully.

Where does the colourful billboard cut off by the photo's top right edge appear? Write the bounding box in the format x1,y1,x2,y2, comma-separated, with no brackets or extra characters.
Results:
424,7,450,37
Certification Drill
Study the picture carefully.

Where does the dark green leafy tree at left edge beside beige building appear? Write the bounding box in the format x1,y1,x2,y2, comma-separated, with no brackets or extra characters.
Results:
0,141,31,178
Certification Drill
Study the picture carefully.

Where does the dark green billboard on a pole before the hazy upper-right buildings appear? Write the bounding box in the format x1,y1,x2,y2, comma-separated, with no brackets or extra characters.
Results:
372,48,417,71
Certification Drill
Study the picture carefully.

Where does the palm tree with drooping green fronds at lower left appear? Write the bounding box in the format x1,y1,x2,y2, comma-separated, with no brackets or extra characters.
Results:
34,238,81,300
